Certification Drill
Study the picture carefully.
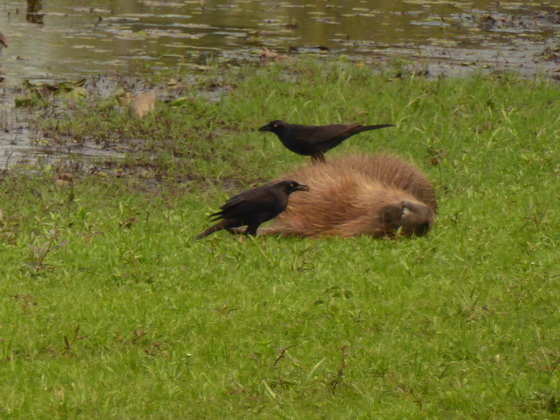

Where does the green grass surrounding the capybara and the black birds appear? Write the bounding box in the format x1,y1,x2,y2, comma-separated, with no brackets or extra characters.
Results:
0,62,560,419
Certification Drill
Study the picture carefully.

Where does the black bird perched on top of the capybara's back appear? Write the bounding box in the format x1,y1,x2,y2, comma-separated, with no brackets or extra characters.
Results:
259,120,395,162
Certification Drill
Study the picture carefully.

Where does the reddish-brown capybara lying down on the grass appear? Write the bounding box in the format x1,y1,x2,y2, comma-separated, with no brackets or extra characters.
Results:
262,154,438,238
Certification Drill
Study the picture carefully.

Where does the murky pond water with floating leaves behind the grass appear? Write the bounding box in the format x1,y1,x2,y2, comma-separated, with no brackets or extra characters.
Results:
0,0,560,167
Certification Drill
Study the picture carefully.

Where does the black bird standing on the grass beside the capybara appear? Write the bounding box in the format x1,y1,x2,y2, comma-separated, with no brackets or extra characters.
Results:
196,180,309,239
